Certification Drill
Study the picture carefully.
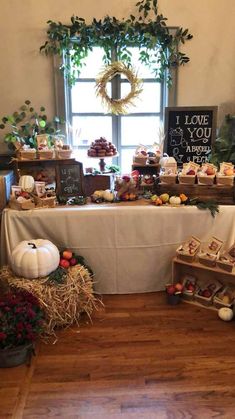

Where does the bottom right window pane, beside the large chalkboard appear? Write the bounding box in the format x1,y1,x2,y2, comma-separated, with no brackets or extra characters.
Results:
121,116,160,145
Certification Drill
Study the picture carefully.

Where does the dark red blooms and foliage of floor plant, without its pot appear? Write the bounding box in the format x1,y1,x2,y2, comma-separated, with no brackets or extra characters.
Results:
0,291,44,349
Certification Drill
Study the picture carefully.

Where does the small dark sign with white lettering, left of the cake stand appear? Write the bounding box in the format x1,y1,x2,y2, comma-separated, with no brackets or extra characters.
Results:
56,161,83,196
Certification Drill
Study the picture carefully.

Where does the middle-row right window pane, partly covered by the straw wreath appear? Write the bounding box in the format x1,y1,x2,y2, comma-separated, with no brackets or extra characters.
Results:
121,83,161,113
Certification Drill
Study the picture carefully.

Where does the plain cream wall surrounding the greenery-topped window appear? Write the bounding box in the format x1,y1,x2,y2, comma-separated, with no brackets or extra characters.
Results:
0,0,235,152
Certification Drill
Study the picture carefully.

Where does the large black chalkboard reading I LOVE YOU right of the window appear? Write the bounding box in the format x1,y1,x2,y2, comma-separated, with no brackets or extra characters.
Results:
164,106,217,165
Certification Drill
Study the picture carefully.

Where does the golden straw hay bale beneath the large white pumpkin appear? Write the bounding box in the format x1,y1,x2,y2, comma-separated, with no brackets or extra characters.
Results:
1,265,98,335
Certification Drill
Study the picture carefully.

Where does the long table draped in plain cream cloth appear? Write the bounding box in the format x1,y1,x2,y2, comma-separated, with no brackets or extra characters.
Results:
1,201,235,294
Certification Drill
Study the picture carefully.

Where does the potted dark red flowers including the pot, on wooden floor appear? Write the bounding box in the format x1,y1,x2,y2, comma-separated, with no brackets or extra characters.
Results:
0,290,44,367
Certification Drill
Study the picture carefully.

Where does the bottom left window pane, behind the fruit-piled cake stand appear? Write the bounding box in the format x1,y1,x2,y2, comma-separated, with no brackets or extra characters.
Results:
72,116,112,147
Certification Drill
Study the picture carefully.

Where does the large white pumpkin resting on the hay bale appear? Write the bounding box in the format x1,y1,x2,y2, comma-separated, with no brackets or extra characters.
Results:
11,239,60,278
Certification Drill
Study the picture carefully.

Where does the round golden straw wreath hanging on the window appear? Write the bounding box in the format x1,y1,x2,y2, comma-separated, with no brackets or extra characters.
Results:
96,61,143,115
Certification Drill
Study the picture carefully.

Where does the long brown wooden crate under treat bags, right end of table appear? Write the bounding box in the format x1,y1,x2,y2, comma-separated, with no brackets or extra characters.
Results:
156,183,235,205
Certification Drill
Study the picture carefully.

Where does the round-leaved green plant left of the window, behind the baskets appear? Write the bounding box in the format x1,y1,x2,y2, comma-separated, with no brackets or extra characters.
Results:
0,100,64,150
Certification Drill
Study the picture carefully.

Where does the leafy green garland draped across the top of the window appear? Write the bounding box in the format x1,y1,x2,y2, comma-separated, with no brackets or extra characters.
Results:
40,0,192,84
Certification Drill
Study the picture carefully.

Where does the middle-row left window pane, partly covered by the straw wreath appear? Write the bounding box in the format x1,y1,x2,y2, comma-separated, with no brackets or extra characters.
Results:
71,82,111,113
